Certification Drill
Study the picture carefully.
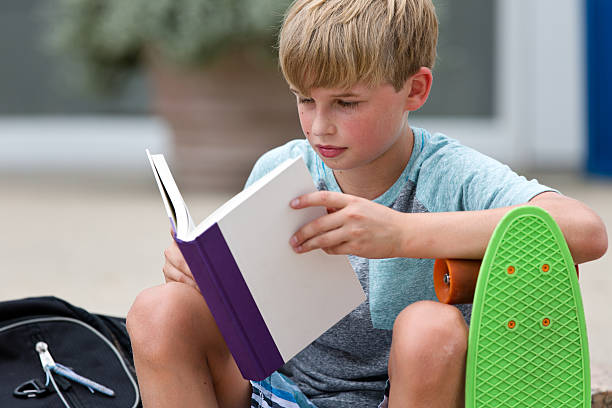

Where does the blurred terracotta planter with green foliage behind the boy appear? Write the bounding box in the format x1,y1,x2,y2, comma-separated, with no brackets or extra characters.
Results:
47,0,299,190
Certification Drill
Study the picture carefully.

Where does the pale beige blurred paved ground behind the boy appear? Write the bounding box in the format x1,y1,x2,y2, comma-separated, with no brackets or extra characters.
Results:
0,170,612,367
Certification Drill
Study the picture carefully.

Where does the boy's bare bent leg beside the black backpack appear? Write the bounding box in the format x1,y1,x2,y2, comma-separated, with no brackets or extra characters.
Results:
127,283,251,408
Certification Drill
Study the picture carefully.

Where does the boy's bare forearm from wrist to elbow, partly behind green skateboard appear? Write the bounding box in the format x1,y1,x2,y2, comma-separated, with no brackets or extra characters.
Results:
400,193,607,263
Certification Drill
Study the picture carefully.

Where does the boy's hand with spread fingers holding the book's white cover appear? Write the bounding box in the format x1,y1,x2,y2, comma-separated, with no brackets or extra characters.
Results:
289,191,403,258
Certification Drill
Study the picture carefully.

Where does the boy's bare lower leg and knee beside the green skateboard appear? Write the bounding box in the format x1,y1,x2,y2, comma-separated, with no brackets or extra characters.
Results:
389,301,468,408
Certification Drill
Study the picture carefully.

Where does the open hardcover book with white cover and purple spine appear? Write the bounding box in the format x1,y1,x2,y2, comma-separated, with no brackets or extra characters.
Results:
147,150,365,380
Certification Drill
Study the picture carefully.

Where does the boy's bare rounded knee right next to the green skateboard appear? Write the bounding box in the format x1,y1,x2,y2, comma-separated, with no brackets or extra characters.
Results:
393,301,468,364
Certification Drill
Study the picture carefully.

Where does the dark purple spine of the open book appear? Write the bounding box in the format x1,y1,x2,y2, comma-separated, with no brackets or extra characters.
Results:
177,224,285,380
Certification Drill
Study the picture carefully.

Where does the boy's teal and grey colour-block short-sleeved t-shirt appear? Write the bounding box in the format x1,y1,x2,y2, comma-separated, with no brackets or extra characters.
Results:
247,128,555,407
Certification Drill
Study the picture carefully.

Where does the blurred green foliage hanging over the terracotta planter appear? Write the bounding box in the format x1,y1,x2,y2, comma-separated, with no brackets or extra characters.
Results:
44,0,290,91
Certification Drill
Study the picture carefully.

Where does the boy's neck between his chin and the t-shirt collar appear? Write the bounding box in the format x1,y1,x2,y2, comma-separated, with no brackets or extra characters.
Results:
333,126,414,200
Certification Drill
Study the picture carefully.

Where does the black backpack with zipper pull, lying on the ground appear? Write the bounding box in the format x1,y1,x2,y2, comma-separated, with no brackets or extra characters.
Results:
0,297,142,408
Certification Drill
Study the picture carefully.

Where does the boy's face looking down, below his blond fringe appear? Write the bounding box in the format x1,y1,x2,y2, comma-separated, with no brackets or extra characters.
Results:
292,84,410,170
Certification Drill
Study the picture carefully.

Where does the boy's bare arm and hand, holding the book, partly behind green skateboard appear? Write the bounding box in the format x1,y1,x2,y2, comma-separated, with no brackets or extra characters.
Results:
290,191,608,263
